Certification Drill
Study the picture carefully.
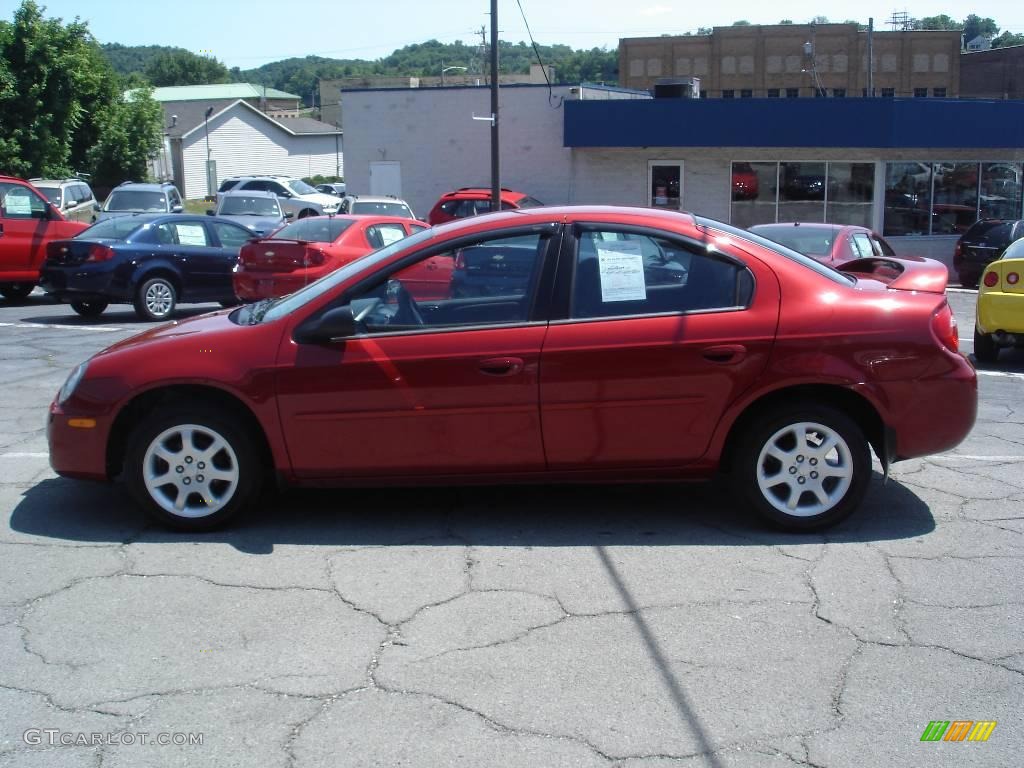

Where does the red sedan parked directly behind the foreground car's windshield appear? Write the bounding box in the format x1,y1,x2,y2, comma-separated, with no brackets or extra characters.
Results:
232,216,429,301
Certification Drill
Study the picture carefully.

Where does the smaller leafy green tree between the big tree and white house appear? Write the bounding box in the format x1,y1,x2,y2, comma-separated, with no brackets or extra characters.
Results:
88,86,164,186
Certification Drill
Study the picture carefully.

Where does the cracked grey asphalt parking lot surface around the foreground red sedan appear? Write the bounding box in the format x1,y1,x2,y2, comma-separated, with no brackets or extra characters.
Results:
0,291,1024,768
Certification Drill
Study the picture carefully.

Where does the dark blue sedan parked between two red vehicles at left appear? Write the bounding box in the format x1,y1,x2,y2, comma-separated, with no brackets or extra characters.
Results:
40,213,253,321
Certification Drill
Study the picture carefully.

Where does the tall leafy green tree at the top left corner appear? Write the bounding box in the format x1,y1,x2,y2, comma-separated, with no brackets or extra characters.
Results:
0,0,117,176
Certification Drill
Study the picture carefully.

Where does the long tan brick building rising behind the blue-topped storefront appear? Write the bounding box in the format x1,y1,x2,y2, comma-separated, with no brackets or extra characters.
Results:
618,24,961,98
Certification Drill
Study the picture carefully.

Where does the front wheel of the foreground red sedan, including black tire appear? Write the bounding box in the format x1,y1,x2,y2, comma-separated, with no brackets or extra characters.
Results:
124,404,265,530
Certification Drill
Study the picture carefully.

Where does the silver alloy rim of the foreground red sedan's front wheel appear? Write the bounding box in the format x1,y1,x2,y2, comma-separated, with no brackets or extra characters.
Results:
142,424,239,518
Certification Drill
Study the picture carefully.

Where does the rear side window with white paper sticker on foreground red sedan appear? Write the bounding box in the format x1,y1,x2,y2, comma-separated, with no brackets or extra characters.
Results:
571,229,754,319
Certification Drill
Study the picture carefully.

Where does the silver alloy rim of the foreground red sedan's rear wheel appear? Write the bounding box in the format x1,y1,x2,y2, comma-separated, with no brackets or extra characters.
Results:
757,422,853,517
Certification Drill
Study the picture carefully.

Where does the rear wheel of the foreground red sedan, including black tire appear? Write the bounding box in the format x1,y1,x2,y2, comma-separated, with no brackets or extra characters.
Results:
734,403,871,530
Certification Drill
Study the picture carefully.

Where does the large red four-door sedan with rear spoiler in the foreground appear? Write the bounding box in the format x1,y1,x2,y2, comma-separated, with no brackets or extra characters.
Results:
47,207,977,529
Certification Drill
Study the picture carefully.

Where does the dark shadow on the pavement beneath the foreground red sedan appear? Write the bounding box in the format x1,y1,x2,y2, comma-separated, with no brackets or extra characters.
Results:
10,473,935,554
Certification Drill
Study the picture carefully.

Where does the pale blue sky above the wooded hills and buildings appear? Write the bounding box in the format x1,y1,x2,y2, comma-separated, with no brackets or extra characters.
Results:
22,0,1024,70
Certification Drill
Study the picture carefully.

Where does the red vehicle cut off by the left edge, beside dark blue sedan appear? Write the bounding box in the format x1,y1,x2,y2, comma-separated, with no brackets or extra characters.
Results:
0,176,89,301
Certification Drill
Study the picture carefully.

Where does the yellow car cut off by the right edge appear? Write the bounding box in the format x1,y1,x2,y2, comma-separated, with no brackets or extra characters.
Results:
974,240,1024,362
